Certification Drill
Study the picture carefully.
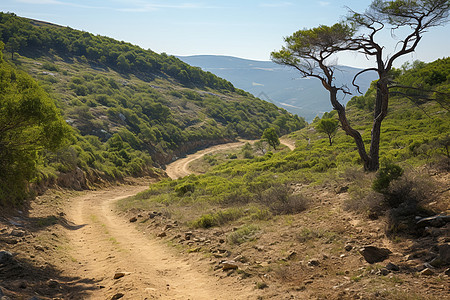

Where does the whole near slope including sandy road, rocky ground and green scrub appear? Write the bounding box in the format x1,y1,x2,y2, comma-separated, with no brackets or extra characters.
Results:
0,58,450,300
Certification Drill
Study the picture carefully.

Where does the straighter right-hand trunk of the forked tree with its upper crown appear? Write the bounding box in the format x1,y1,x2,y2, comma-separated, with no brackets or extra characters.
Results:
347,0,450,171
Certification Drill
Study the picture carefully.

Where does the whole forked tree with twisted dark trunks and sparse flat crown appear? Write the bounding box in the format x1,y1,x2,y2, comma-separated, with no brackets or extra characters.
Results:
272,0,450,171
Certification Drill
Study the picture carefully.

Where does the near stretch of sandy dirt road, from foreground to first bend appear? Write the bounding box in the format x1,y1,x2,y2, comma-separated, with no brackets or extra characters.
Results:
66,186,253,299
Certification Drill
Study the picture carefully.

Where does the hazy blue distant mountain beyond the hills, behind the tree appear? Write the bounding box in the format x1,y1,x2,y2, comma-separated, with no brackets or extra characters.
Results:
179,55,376,122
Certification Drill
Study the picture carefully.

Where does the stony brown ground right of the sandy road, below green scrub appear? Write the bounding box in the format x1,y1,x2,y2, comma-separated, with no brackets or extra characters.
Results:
121,179,450,299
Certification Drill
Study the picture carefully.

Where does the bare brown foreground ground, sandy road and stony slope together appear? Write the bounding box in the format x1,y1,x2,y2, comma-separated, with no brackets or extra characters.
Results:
0,161,450,300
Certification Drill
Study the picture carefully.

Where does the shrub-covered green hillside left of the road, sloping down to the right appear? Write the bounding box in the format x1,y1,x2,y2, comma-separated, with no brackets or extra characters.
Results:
0,13,306,204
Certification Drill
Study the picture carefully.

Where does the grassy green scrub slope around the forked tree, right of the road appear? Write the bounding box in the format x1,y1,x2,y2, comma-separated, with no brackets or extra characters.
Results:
123,58,450,227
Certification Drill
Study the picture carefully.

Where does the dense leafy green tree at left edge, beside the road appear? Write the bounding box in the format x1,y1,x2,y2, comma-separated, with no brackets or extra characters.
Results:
0,42,71,206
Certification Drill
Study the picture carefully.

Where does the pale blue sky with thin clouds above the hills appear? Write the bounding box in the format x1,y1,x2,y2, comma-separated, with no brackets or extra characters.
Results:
0,0,450,67
